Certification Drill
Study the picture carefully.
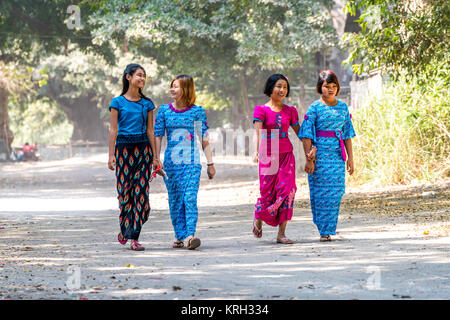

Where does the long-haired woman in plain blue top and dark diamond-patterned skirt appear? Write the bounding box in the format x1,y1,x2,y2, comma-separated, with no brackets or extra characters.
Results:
108,64,160,251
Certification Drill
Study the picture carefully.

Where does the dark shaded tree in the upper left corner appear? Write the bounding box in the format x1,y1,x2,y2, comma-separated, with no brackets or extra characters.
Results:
0,0,113,149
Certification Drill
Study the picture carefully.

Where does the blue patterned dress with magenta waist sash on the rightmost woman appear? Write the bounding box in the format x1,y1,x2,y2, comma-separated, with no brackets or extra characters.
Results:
298,100,356,236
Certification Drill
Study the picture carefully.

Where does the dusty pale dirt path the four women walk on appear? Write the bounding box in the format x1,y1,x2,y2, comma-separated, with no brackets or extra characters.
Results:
0,154,450,300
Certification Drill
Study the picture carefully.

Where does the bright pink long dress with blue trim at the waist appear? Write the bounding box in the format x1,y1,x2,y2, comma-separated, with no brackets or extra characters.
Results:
253,105,299,226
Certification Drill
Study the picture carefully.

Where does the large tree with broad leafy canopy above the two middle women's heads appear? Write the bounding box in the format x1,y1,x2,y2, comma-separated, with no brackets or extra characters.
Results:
90,0,336,124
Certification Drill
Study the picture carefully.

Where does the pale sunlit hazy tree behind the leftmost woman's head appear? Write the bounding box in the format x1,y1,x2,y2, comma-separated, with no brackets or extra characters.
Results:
39,46,161,142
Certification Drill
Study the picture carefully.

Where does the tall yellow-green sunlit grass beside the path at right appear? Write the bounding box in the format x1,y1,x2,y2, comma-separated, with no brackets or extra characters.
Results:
351,74,450,184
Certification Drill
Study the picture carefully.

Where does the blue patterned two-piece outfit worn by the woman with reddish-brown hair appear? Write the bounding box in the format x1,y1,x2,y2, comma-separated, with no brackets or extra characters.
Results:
155,104,209,240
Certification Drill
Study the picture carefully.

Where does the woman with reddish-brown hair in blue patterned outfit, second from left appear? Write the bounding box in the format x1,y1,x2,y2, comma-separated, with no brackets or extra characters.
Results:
155,75,216,249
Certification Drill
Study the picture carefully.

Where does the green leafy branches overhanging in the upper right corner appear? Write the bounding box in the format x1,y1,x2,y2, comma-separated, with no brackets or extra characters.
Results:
344,0,450,82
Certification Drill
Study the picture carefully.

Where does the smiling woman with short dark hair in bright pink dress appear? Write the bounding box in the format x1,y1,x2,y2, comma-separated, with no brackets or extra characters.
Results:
253,74,315,244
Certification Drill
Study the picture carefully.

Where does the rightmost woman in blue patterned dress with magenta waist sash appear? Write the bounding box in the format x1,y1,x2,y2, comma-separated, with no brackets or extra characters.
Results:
298,70,356,241
